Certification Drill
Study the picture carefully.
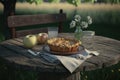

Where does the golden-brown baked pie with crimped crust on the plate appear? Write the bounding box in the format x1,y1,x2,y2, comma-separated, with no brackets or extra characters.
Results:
47,38,81,53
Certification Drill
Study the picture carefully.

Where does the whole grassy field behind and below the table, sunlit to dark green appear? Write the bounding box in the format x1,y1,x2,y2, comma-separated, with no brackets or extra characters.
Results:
0,3,120,80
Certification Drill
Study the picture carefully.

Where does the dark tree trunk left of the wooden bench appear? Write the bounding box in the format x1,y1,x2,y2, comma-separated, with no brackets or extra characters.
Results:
0,0,16,39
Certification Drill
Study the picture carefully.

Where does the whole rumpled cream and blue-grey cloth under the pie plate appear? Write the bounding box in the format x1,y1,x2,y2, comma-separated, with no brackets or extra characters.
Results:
27,49,99,73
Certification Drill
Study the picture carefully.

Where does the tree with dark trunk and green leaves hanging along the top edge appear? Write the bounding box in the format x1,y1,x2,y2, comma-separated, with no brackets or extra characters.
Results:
0,0,80,39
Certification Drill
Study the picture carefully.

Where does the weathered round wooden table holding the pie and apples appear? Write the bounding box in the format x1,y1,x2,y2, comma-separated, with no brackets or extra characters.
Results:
0,33,120,80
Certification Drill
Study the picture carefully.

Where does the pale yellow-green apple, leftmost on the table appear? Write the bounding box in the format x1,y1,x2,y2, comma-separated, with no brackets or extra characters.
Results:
23,35,37,48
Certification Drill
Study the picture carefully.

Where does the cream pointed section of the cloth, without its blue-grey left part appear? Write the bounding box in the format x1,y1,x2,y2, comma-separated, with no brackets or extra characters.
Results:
52,49,99,73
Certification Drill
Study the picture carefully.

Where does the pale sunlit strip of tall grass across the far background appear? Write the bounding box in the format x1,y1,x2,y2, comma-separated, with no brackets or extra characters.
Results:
0,2,120,13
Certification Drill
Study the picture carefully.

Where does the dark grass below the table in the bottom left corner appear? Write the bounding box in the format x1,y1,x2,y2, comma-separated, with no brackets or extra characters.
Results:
0,59,38,80
